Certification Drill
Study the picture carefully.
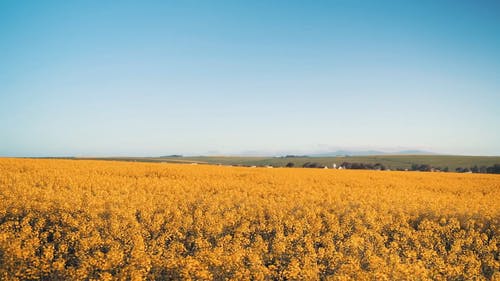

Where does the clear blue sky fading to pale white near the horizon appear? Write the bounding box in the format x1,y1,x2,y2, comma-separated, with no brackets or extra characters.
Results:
0,0,500,156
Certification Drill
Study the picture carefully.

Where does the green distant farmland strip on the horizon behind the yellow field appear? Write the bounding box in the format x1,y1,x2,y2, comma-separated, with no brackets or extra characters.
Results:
69,155,500,171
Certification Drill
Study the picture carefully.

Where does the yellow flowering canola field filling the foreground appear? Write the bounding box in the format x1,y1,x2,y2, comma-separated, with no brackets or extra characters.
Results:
0,159,500,280
